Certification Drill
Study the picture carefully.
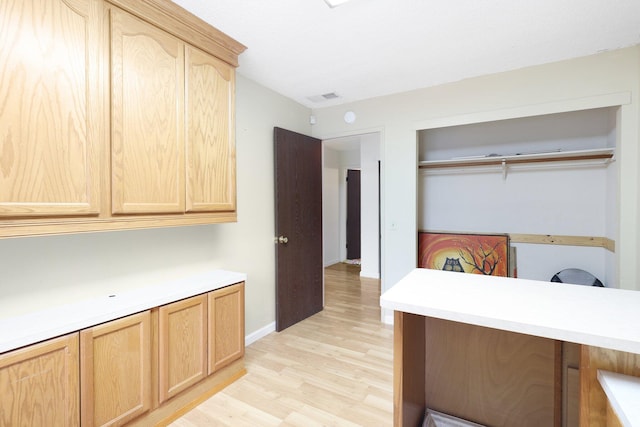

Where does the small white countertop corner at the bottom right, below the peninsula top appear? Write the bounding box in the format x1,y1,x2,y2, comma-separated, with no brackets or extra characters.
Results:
598,370,640,427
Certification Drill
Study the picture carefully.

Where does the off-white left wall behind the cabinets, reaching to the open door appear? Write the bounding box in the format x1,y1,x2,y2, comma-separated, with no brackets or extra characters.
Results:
0,75,311,342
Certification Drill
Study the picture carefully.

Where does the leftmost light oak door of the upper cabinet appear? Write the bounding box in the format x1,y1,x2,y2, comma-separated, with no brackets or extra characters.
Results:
0,0,102,218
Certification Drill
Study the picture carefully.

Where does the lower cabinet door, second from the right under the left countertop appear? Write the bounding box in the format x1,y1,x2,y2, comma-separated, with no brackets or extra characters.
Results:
159,294,207,403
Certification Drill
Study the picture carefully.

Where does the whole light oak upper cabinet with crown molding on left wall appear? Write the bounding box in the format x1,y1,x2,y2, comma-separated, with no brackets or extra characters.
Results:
0,0,245,237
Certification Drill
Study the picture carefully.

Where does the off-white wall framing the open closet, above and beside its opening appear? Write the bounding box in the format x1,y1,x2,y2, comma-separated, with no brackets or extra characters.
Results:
313,46,640,320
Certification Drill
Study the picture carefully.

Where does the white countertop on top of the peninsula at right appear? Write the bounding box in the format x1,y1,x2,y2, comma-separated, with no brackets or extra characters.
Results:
380,268,640,354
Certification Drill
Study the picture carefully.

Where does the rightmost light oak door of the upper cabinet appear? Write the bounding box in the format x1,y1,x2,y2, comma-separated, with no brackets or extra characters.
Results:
185,46,236,212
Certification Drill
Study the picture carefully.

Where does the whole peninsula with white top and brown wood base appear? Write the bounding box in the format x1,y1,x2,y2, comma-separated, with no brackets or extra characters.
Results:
380,269,640,427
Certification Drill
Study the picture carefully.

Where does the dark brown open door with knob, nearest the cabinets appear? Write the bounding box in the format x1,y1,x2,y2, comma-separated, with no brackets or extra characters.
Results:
274,128,323,331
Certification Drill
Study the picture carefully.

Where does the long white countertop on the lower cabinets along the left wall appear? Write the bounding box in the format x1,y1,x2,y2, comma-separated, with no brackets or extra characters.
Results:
0,270,246,353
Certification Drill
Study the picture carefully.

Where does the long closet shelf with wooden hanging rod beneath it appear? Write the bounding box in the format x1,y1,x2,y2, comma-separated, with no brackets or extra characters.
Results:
418,148,615,169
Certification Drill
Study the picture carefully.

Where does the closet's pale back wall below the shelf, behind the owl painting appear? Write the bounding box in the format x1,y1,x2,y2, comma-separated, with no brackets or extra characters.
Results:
418,166,617,285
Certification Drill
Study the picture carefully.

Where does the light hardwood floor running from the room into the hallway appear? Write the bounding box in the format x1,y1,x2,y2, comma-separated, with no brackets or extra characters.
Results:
171,264,393,427
